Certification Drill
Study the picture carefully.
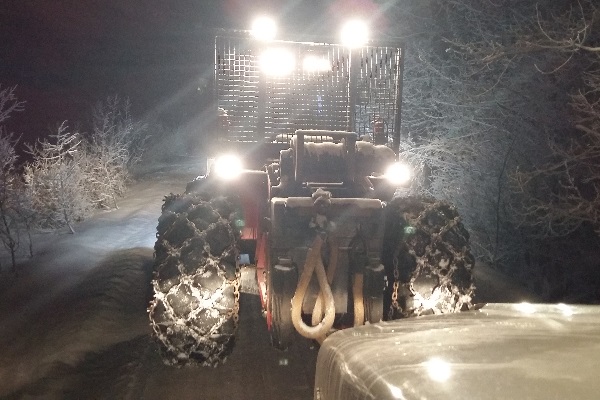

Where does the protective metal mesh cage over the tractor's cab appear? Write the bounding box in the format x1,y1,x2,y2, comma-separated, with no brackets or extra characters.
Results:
215,36,401,143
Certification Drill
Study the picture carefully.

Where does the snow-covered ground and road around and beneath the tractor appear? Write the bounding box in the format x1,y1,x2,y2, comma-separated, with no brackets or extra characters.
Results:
0,161,531,400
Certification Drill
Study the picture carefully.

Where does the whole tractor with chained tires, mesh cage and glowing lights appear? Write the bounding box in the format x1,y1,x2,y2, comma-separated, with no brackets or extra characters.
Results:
149,17,474,366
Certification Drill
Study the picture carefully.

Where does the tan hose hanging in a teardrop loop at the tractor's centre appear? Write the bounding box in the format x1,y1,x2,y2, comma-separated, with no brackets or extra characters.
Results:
292,235,335,339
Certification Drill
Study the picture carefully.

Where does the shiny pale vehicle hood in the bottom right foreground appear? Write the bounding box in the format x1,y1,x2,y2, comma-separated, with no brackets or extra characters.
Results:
314,303,600,400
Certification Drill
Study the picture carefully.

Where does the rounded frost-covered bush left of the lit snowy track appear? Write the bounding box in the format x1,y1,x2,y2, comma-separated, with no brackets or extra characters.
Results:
24,123,92,233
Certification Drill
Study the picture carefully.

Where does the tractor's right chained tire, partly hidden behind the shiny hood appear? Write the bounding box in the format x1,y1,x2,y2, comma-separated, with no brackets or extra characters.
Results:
383,196,475,319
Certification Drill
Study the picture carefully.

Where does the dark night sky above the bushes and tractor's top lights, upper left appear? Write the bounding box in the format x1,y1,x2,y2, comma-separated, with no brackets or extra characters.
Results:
0,0,380,144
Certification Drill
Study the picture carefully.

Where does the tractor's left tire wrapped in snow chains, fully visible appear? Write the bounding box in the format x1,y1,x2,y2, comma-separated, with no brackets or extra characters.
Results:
149,194,239,366
